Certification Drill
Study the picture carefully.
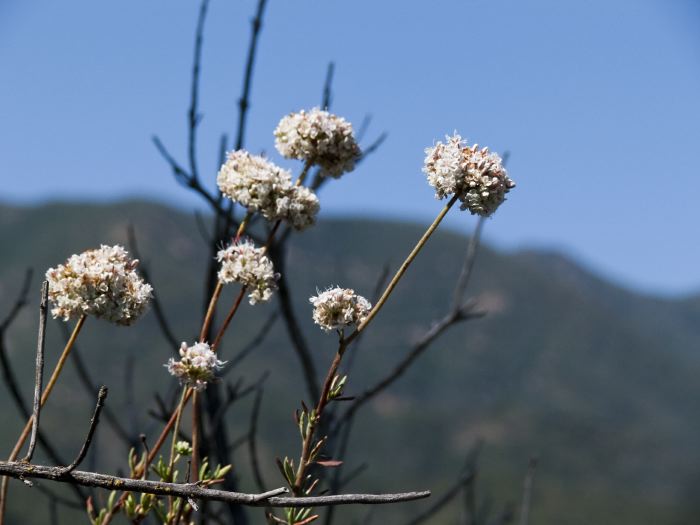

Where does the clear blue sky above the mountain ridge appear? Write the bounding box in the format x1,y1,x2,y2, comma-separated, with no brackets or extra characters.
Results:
0,0,700,294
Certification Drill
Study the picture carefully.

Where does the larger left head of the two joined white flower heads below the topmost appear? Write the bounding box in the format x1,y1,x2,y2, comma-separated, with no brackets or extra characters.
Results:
216,150,292,221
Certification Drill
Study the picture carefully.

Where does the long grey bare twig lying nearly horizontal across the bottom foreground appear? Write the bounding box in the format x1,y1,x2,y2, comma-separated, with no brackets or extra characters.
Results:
0,461,430,508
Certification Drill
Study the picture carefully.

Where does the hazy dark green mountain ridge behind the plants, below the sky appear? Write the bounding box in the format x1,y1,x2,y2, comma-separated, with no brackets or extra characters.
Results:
0,201,700,525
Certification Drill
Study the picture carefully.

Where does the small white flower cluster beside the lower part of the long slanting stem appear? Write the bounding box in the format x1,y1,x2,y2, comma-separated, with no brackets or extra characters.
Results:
309,286,372,332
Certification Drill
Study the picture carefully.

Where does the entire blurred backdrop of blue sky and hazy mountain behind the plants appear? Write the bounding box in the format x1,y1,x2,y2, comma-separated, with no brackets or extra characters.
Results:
0,0,700,524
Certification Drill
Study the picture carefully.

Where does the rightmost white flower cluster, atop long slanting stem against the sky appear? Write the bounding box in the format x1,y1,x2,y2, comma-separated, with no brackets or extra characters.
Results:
423,134,515,217
